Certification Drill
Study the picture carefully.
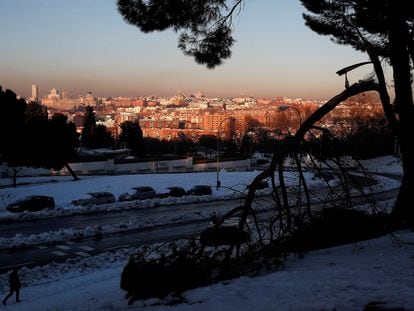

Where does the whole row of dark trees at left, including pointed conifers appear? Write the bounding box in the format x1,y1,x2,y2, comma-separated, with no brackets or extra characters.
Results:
0,86,144,186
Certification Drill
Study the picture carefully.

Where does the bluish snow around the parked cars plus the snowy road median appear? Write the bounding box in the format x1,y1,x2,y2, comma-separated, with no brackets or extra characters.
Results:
0,157,401,249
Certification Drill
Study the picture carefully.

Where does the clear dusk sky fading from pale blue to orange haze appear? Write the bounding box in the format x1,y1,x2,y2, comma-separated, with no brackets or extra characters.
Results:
0,0,371,100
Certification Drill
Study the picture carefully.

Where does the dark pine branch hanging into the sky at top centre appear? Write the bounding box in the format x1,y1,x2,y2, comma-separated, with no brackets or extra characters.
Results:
118,0,243,68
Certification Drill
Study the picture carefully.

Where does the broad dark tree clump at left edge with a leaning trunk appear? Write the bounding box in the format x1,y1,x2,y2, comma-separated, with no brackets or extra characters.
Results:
0,88,79,186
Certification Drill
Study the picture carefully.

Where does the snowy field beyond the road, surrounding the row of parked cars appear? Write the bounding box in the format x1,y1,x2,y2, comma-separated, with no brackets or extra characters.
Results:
0,156,401,221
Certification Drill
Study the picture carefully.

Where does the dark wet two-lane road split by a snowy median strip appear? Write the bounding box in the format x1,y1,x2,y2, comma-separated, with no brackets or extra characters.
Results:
0,177,398,273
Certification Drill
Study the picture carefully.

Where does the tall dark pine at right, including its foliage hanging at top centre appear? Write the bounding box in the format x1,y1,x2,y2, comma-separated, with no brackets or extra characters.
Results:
118,0,414,224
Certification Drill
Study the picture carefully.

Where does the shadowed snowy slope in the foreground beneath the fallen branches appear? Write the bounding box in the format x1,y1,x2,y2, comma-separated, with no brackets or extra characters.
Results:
2,231,414,311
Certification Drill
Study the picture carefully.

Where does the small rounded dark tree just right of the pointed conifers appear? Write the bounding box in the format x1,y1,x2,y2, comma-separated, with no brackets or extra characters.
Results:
118,121,145,156
